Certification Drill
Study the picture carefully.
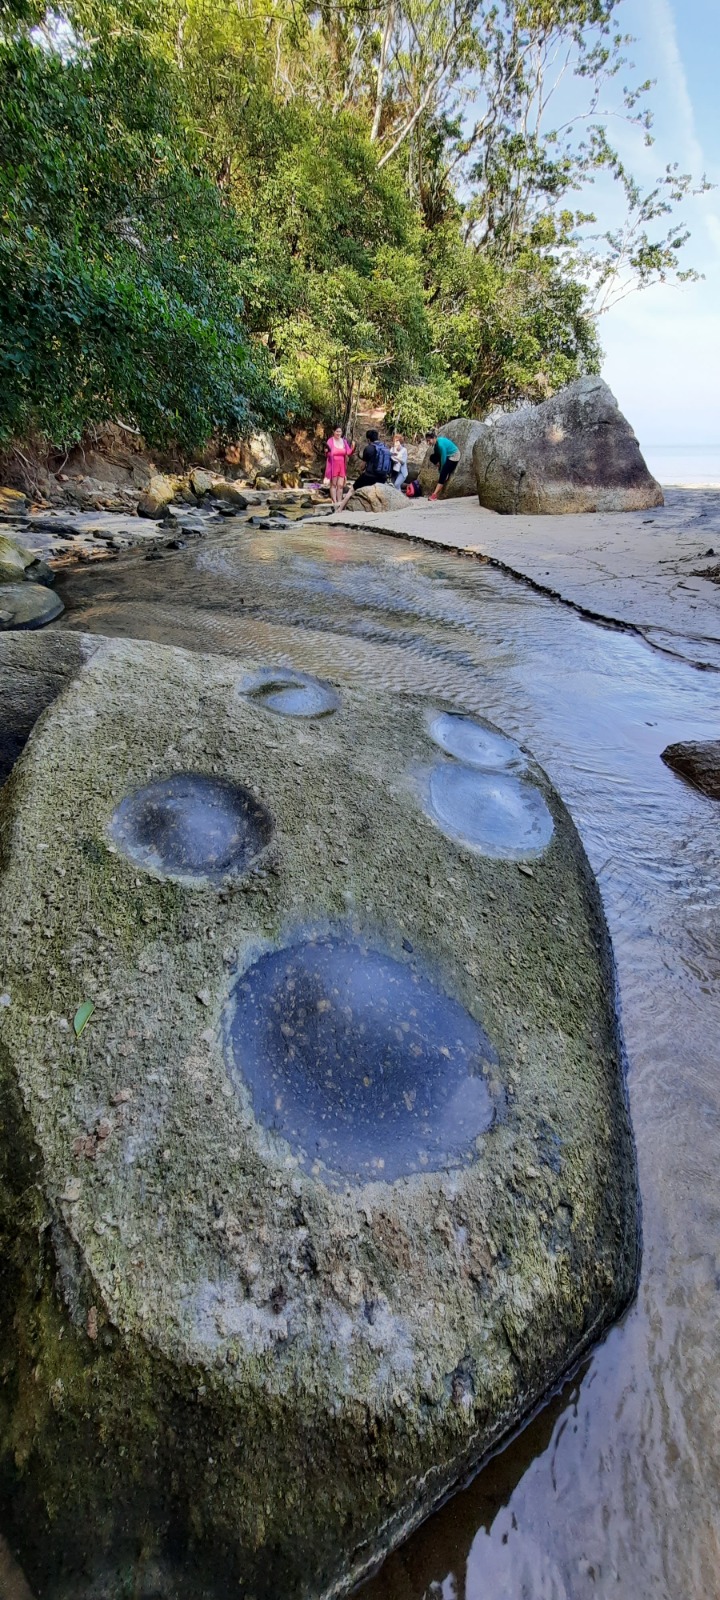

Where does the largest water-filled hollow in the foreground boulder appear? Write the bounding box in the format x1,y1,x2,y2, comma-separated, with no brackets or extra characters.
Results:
229,934,498,1182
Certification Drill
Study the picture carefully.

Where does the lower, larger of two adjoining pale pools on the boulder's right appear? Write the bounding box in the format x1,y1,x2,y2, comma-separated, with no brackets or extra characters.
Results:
427,762,554,861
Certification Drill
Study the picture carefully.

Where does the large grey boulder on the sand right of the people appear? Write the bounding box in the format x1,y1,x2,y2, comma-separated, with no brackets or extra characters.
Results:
472,378,662,514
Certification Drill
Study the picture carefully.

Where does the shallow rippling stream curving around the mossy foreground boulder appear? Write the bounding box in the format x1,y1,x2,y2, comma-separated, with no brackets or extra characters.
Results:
46,523,720,1600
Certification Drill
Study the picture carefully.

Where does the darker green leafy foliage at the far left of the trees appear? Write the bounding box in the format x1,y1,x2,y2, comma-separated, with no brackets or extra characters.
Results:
0,35,285,450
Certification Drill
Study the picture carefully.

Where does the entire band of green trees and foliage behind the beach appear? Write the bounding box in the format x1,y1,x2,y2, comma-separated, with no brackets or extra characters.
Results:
0,0,704,451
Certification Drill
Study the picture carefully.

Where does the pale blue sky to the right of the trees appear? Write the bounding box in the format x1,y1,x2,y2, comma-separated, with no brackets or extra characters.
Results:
600,0,720,446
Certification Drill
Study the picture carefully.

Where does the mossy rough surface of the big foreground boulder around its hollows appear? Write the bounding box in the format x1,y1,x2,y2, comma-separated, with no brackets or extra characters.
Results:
0,642,637,1600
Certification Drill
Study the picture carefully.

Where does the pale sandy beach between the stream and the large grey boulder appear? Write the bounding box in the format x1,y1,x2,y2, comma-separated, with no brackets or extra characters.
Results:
331,488,720,670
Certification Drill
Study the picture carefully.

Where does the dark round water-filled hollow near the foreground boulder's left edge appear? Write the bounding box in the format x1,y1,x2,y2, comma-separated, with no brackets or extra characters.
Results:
110,773,274,883
